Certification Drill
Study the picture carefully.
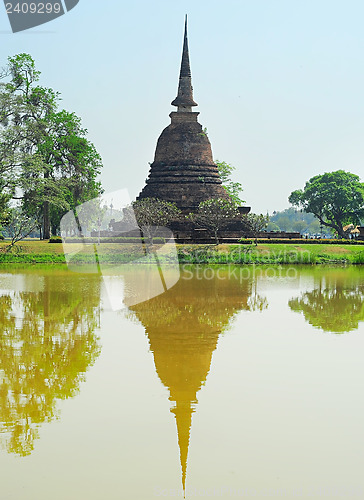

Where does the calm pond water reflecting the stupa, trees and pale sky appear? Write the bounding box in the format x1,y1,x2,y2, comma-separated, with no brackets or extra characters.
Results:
0,266,364,500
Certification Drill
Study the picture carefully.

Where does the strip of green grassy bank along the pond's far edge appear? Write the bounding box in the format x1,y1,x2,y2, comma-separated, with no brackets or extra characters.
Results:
0,241,364,264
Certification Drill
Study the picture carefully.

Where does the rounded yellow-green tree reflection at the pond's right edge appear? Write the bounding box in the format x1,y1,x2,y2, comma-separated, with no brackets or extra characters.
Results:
288,271,364,333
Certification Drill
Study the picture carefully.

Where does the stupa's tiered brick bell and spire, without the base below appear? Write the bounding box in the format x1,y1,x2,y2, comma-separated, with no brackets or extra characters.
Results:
137,16,236,213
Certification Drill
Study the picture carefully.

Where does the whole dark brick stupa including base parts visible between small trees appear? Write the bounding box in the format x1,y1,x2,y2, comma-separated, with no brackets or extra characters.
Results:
107,16,250,243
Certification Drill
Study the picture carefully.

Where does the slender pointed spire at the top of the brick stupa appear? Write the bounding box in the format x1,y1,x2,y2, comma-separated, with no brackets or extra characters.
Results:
171,14,197,113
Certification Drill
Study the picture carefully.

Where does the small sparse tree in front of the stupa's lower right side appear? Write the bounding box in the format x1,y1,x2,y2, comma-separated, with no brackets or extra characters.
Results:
188,198,239,245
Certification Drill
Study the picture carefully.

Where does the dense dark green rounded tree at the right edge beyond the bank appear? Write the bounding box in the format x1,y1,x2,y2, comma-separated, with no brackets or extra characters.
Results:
288,170,364,238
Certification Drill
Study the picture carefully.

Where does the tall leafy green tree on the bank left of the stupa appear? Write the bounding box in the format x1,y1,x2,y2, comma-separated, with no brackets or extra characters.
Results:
0,54,102,238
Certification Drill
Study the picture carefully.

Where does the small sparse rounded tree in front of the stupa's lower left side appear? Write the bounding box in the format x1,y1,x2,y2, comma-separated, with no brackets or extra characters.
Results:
124,198,181,243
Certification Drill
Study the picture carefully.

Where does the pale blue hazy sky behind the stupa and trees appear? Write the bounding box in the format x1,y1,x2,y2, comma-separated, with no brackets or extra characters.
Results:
0,0,364,212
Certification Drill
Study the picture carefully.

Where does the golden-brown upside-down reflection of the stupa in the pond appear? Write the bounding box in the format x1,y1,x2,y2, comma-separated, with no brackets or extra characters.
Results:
124,267,268,492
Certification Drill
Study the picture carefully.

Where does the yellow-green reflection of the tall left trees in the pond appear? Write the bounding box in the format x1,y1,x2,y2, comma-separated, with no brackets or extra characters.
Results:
0,274,100,456
